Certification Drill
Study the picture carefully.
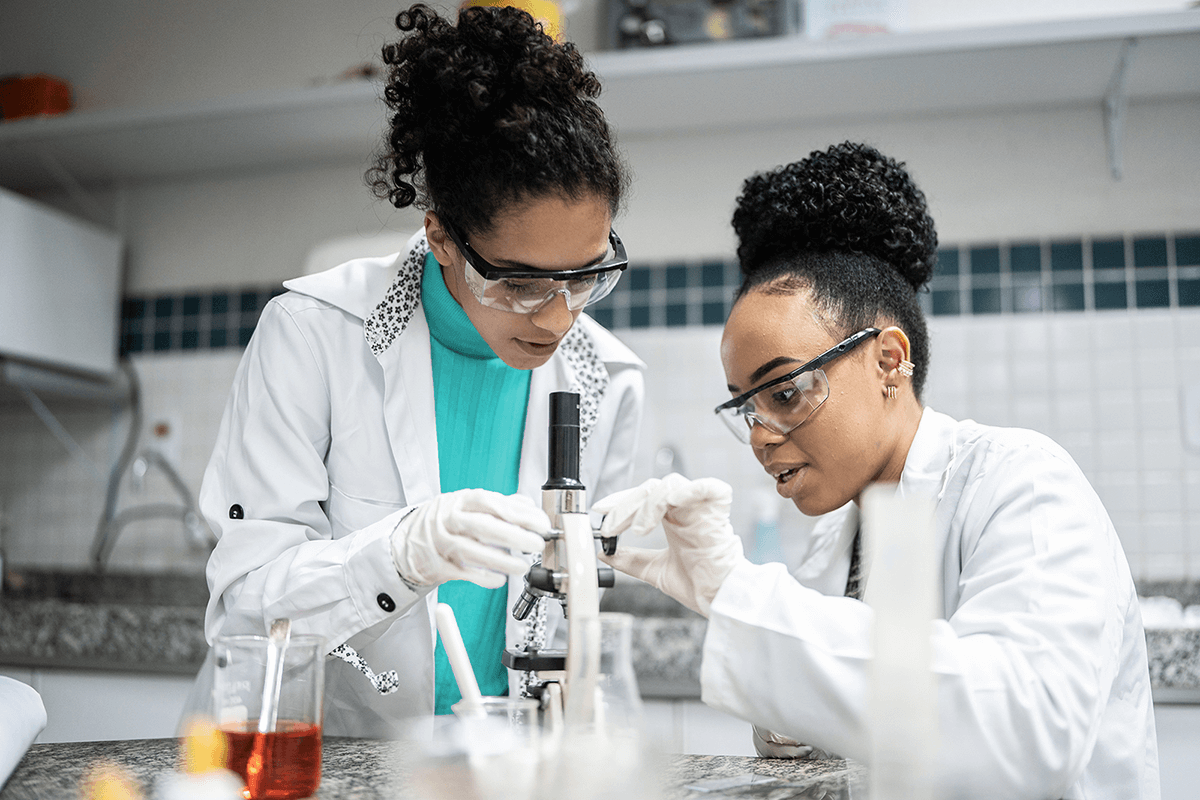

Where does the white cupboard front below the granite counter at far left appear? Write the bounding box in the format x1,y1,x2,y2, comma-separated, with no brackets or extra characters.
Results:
0,667,192,744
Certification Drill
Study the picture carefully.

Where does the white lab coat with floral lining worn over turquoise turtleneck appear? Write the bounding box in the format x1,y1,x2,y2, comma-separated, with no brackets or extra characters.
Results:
200,231,644,736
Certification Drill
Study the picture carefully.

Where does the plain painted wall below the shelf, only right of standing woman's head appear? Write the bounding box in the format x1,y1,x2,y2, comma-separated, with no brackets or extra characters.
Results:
620,101,1200,260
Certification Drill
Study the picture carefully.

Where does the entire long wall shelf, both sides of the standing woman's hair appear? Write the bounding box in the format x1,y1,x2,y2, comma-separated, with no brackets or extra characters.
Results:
0,11,1200,190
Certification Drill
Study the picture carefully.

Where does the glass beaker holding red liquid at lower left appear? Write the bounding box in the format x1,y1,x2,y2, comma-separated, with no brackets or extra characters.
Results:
212,634,325,800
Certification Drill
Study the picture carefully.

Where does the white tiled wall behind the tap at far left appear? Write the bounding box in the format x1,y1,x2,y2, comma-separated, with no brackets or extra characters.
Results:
0,350,240,572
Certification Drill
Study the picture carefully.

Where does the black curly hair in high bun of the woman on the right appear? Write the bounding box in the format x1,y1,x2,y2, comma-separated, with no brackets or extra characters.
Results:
733,142,937,399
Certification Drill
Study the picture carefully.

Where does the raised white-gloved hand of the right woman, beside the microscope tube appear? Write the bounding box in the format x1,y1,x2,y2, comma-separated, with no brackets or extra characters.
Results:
592,473,744,616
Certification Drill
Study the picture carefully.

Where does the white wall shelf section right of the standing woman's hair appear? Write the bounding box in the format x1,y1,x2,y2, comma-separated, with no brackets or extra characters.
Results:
593,12,1200,134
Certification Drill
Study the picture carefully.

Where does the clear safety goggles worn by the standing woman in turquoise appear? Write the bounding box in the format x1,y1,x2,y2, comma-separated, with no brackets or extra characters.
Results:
442,219,629,314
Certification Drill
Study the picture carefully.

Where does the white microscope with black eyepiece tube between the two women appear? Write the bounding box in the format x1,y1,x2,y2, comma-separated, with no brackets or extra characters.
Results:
502,392,617,730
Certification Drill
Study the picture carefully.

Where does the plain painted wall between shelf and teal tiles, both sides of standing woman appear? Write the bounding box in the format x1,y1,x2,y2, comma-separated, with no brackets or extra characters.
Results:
105,95,1200,294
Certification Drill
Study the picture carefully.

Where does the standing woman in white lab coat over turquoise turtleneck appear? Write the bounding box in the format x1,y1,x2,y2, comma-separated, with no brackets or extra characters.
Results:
200,6,643,736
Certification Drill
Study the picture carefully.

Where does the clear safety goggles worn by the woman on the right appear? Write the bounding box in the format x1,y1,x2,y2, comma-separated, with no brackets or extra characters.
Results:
715,327,880,444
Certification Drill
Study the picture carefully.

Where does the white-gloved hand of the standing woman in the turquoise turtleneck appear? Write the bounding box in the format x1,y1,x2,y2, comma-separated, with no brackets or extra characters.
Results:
391,489,550,589
